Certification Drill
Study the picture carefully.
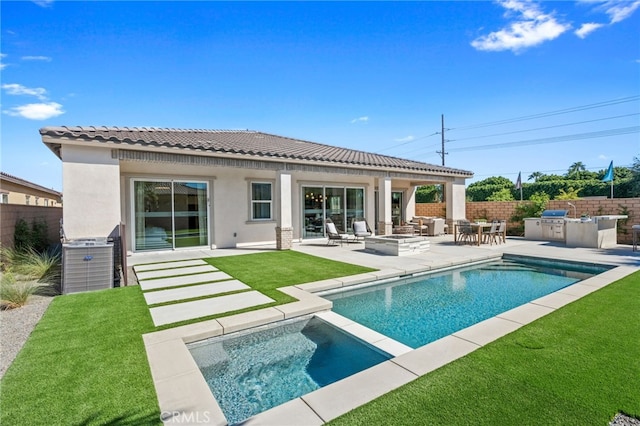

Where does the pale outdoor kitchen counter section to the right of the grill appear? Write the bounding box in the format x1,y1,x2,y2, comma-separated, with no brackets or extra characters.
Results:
565,215,628,248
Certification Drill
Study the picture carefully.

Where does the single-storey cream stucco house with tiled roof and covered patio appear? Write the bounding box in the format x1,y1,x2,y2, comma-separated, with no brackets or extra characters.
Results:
40,127,473,252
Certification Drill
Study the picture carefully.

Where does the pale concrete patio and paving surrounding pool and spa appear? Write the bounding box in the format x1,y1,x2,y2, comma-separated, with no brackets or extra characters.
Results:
129,236,640,425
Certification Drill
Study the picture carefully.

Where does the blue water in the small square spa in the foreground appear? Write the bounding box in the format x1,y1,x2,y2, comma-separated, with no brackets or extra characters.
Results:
188,317,391,424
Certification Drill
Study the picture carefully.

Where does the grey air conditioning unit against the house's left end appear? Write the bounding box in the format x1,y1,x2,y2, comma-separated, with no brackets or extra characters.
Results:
62,238,113,294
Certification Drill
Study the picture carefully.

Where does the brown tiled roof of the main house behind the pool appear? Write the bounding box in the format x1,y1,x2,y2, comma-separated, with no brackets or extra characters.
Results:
40,126,473,177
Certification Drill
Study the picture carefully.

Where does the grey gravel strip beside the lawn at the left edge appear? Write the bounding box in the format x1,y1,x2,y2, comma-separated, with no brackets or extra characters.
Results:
0,296,53,378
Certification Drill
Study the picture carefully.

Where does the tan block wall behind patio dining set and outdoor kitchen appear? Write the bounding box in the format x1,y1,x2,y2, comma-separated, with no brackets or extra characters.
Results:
416,198,640,244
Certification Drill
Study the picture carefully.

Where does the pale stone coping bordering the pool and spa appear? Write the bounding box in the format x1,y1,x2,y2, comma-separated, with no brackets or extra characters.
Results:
142,253,637,425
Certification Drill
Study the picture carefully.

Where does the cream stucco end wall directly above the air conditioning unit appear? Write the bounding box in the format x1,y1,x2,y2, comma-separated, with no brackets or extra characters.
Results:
61,145,120,239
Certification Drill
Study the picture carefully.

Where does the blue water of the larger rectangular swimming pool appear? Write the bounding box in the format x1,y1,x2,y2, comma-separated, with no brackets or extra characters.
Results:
323,259,608,348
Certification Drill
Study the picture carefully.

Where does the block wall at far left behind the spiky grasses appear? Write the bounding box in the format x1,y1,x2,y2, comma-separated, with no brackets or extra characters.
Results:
0,204,62,247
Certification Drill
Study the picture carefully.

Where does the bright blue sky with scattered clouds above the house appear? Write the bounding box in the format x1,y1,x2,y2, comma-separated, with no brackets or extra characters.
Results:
0,0,640,190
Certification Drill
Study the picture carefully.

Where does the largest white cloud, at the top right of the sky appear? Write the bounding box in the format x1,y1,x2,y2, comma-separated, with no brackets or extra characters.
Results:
471,0,571,52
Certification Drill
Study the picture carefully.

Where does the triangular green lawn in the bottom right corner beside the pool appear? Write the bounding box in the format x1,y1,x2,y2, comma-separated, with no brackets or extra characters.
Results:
330,272,640,426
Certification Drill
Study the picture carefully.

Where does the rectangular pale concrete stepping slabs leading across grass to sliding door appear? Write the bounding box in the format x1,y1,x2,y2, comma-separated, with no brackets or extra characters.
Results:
133,259,274,327
